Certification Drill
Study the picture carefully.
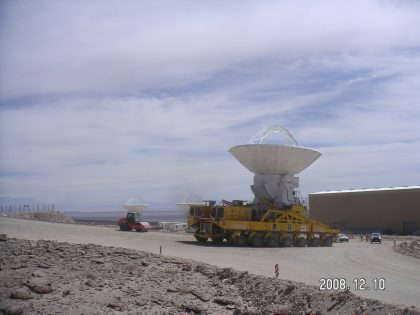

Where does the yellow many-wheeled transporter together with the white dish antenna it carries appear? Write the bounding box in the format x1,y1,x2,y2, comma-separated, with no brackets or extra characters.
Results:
188,125,339,247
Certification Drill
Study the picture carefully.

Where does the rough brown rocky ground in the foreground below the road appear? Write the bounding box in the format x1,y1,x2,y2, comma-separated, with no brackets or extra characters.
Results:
0,236,420,315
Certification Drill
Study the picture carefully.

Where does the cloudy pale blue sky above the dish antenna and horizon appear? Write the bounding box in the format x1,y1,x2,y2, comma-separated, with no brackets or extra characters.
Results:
0,0,420,210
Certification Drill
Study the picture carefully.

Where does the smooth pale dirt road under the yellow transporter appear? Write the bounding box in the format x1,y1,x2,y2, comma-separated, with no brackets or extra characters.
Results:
0,217,420,307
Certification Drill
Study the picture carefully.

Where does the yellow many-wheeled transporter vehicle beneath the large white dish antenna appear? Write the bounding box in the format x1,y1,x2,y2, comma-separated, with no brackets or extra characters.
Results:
188,200,339,247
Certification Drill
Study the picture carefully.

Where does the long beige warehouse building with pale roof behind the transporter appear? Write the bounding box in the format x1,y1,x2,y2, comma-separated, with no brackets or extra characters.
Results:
309,186,420,234
